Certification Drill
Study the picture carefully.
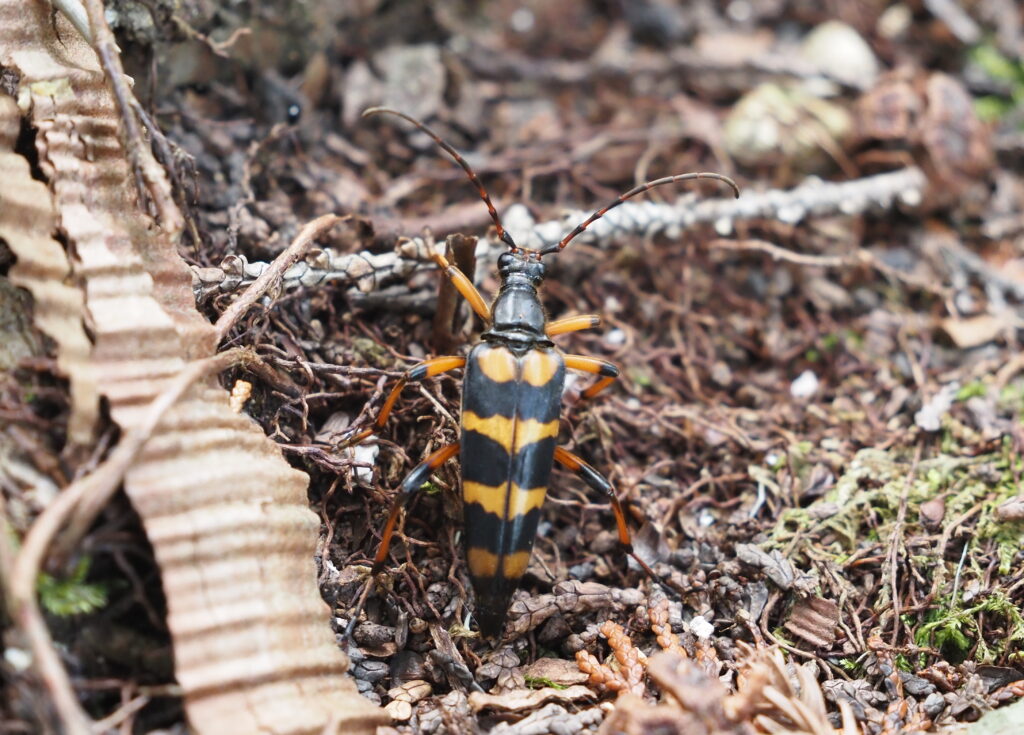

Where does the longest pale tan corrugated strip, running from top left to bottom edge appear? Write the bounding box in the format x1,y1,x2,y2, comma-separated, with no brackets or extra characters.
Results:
0,0,384,733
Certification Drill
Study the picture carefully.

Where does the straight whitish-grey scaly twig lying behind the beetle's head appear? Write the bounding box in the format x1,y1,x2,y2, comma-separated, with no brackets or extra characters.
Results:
193,167,927,299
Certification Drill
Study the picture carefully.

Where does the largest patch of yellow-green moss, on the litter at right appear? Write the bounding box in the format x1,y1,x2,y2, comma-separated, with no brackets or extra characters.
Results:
751,438,1024,671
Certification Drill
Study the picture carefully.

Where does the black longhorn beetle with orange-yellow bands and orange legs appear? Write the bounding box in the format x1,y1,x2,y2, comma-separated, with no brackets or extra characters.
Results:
345,107,739,638
